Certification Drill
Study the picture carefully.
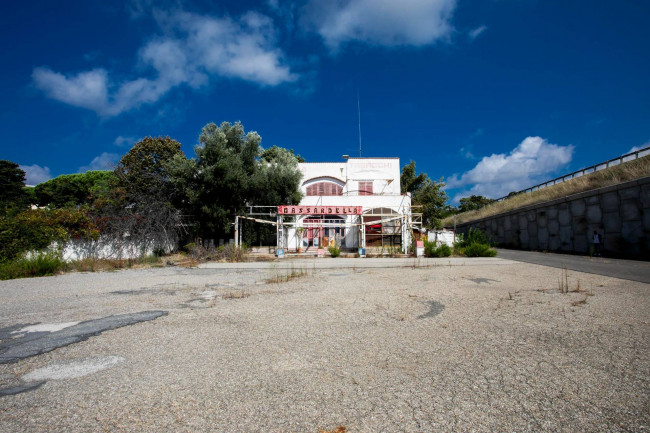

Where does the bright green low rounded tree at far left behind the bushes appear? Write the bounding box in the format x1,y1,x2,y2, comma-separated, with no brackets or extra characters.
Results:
34,171,115,208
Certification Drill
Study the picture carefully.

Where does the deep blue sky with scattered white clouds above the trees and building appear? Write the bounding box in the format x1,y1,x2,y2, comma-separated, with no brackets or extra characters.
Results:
0,0,650,201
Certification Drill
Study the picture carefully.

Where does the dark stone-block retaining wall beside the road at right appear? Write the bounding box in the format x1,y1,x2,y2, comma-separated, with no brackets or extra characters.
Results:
457,177,650,260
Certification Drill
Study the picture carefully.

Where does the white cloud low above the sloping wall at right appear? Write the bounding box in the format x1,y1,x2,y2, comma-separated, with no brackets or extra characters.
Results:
447,137,574,202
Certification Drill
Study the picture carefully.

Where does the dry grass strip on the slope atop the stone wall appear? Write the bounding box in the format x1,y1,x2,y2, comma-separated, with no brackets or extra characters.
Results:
442,156,650,227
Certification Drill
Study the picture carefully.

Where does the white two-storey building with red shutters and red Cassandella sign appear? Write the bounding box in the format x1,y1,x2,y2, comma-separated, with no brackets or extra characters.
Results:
278,158,413,252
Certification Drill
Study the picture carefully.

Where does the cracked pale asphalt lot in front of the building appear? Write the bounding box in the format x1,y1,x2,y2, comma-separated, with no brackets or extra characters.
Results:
0,258,650,433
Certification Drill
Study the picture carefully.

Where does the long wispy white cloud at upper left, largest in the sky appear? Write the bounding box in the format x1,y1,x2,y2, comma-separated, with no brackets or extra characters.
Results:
32,11,298,117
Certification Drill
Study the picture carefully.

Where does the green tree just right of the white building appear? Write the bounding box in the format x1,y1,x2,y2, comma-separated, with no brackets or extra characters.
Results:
400,161,448,228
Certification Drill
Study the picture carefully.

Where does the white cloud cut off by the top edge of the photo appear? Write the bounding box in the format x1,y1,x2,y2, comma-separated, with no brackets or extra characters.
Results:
305,0,456,50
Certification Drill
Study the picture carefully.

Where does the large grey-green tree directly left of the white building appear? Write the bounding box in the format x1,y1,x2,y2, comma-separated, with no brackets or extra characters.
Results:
181,122,301,242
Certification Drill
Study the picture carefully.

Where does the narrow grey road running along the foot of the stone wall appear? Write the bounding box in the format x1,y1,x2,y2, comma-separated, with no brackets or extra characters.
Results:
498,249,650,283
